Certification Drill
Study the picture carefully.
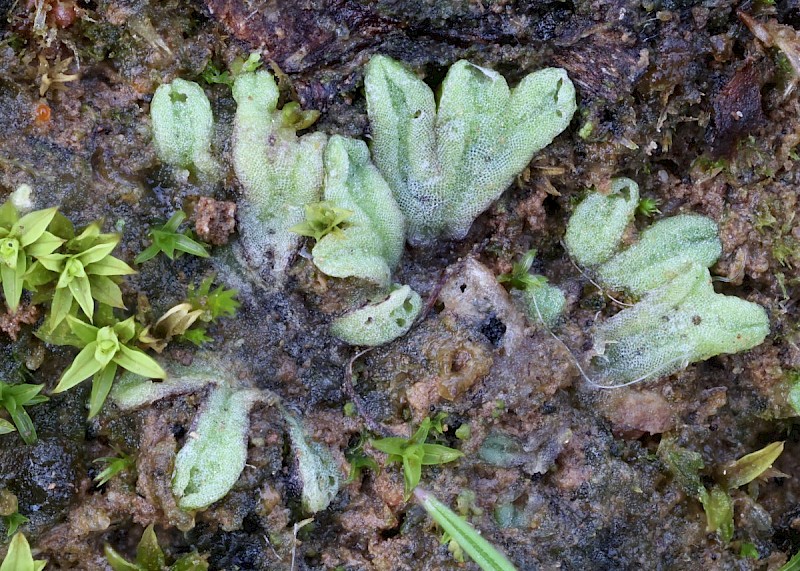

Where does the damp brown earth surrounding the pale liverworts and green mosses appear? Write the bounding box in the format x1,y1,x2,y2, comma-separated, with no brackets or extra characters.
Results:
0,0,800,570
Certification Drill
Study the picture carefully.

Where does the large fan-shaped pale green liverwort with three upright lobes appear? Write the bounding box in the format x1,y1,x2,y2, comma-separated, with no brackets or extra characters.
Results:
364,55,576,245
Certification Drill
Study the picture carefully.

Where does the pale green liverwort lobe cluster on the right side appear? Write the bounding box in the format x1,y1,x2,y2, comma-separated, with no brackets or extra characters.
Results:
565,178,769,387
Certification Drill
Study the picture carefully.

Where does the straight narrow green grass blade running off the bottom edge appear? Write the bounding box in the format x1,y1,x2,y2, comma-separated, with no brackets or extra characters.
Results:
414,488,516,571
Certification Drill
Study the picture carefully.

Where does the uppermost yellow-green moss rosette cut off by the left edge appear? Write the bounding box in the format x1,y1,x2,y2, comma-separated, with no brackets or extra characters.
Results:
0,200,59,312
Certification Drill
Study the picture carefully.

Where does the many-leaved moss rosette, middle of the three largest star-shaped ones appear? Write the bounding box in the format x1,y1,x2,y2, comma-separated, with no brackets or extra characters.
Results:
30,220,136,332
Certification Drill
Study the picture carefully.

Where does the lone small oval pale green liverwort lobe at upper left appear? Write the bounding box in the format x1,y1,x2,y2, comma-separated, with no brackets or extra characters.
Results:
150,79,220,177
